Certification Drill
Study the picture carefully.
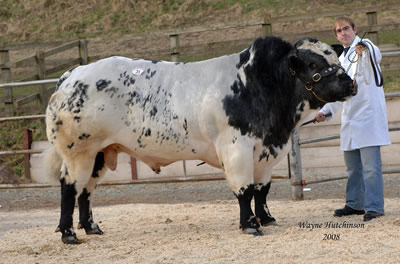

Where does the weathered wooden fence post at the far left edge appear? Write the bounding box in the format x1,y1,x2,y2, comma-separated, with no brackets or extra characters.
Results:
0,49,15,116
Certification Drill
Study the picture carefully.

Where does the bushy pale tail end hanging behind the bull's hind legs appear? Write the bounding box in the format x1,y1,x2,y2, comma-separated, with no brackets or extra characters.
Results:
41,145,63,183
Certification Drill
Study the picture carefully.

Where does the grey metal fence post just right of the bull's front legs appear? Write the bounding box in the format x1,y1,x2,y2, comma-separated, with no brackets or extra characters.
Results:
290,128,304,200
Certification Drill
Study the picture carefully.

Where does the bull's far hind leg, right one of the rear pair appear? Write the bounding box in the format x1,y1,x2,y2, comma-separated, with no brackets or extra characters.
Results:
78,152,107,235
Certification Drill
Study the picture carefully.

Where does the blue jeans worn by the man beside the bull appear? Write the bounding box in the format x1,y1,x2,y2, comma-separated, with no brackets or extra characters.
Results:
344,146,384,214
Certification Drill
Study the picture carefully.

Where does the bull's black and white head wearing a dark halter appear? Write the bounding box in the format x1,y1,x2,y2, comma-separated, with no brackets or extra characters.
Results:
288,38,357,107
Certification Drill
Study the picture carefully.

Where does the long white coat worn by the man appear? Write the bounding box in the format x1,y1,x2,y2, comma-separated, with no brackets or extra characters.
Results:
320,36,391,151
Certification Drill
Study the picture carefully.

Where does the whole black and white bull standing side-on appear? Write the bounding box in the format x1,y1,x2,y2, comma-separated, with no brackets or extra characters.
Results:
46,37,355,244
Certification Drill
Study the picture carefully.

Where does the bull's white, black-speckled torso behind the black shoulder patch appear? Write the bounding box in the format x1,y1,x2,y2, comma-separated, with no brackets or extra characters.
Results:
47,55,241,165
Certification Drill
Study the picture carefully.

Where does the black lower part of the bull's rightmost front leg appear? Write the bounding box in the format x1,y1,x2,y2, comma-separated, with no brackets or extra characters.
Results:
254,182,276,226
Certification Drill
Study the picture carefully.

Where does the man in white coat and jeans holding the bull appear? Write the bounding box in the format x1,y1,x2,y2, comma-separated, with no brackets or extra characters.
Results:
315,17,391,221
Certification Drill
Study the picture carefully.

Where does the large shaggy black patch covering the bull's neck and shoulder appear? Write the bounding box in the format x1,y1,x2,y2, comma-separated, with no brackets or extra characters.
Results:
222,37,303,150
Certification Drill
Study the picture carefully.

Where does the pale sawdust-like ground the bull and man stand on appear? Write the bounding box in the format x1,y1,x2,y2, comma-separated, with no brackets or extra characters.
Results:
0,198,400,264
